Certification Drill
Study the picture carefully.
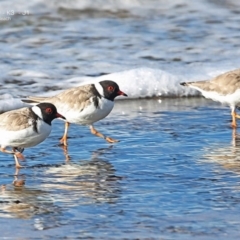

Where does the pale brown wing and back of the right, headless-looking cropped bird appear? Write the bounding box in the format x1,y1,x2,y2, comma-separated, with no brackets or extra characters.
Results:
187,69,240,95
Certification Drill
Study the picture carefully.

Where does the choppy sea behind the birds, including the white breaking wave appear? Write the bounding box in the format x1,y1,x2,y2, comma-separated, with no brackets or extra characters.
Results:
0,0,240,111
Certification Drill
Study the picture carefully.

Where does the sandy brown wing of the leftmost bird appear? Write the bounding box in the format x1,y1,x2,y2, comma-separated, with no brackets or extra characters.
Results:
0,108,34,131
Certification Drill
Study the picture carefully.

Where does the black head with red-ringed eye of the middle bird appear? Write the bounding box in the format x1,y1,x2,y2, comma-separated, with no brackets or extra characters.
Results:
99,80,127,101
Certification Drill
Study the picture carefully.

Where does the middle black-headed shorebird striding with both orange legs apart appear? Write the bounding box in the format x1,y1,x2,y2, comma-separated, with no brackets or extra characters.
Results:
22,80,127,146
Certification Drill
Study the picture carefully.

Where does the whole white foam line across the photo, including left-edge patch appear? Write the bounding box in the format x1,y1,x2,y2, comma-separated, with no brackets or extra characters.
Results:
0,67,237,112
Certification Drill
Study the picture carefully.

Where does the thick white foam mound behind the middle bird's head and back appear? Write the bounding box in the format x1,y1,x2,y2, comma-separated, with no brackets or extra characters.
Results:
66,68,199,99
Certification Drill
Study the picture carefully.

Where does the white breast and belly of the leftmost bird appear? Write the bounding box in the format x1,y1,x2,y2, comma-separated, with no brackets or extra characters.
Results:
0,119,51,148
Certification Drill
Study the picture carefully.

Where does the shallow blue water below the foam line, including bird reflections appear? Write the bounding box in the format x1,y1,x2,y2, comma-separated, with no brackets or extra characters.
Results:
0,98,240,239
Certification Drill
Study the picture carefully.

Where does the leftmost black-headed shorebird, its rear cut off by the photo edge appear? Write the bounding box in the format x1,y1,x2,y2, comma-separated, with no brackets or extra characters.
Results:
0,103,65,168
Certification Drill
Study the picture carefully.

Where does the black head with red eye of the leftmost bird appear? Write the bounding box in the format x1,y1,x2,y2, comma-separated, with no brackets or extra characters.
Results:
36,103,66,125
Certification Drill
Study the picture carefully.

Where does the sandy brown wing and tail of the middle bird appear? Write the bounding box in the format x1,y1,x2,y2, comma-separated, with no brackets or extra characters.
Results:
28,84,96,113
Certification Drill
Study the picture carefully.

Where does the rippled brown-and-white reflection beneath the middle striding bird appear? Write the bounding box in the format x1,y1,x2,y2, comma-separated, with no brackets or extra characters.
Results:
42,146,121,206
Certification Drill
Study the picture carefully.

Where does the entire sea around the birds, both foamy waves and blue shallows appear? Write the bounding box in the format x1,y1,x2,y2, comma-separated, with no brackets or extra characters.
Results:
0,0,240,240
